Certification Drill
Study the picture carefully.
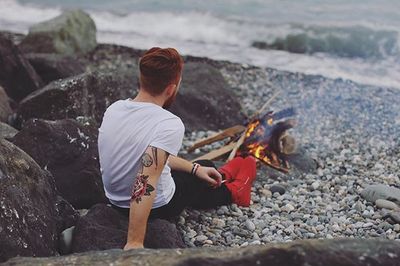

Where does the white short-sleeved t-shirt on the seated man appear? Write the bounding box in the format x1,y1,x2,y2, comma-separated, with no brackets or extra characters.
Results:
98,99,185,208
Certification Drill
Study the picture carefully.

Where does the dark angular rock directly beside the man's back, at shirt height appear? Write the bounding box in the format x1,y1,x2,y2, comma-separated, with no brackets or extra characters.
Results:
12,119,107,209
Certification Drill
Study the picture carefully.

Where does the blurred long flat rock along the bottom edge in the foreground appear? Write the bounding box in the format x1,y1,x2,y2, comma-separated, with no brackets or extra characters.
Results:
3,239,400,266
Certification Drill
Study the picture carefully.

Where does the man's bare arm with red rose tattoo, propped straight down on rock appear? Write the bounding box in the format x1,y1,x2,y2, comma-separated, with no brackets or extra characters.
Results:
124,146,168,250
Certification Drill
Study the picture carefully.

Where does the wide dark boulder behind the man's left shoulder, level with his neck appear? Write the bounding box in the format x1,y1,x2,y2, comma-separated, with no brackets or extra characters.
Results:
17,71,137,126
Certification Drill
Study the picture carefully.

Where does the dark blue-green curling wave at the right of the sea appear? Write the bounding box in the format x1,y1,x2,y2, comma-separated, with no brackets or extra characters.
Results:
252,26,400,59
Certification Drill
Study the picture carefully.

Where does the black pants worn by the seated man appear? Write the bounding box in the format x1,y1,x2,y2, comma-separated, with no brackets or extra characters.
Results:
112,160,232,219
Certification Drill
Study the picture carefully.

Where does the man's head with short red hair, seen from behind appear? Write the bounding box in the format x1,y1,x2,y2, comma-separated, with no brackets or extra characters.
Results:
139,47,183,96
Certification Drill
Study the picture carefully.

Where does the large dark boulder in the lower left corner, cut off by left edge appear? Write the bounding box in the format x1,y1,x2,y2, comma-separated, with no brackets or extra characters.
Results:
0,139,59,262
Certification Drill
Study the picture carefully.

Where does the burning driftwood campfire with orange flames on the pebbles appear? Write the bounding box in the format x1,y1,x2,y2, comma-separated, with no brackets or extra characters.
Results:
188,94,296,172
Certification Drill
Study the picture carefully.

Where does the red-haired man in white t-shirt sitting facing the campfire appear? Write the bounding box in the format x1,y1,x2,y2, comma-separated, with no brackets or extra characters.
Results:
98,48,256,249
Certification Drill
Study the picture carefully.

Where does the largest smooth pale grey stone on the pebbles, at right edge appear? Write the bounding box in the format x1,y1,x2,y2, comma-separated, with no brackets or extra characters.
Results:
361,184,400,204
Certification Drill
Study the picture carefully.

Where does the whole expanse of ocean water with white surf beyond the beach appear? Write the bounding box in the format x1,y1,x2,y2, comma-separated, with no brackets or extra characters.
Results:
0,0,400,88
